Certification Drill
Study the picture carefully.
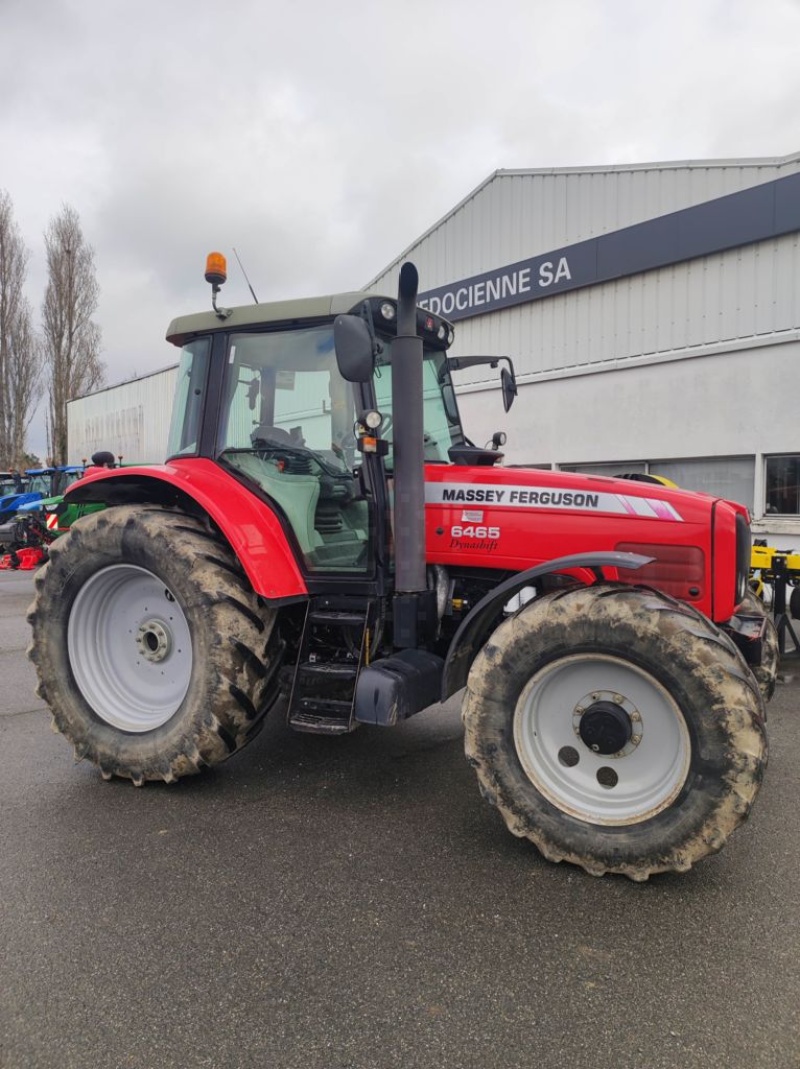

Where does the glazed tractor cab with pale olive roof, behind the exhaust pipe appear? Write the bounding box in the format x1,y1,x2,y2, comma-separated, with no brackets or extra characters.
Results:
168,271,499,575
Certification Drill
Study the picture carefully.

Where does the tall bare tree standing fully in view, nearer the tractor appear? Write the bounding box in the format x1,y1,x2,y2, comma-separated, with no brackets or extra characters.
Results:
42,204,105,464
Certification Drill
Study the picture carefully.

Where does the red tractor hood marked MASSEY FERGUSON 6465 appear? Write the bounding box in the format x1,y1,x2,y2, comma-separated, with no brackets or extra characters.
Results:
425,464,747,615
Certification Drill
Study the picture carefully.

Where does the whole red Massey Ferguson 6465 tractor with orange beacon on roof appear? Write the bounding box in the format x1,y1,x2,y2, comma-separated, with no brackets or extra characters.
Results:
29,254,775,880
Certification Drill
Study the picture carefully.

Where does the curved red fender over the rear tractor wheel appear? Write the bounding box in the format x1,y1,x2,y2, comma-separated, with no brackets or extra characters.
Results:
64,458,308,601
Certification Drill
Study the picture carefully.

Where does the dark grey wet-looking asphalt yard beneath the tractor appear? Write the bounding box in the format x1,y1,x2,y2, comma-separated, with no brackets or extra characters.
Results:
0,572,800,1069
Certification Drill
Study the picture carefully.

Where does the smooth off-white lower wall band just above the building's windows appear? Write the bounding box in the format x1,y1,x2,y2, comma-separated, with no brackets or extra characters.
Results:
459,341,800,465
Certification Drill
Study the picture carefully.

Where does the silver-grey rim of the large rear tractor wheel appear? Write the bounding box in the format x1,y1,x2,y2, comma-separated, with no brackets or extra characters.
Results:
67,564,193,733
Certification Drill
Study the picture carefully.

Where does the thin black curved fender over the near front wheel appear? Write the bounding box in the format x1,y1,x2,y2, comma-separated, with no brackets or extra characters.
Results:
441,552,652,701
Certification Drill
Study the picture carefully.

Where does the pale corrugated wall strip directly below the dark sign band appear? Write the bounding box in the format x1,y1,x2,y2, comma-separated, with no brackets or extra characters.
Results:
442,235,800,381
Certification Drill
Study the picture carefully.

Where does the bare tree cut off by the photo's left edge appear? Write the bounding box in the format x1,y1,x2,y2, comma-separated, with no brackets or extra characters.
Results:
0,190,42,468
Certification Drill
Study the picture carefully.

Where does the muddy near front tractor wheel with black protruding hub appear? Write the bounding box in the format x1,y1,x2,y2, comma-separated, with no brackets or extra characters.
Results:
463,584,767,881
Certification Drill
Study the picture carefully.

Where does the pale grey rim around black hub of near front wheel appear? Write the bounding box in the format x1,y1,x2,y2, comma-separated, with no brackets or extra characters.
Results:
513,654,691,825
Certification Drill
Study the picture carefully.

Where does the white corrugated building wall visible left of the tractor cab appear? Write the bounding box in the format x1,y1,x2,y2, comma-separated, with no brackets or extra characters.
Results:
66,367,178,464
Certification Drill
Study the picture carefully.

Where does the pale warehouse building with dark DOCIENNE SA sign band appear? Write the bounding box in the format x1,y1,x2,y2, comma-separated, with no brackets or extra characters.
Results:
70,153,800,547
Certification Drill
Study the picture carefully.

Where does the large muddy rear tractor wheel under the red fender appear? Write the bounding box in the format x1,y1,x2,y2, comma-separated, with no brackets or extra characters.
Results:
28,506,280,786
